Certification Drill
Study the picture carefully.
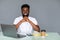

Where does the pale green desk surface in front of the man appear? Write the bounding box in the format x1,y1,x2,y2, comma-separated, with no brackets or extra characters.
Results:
0,32,60,40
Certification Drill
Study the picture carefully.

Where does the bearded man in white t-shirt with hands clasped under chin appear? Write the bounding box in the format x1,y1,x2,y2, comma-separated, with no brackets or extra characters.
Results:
14,4,40,35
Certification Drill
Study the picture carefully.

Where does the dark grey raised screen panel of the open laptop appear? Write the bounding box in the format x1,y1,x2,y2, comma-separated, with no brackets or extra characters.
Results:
1,24,18,38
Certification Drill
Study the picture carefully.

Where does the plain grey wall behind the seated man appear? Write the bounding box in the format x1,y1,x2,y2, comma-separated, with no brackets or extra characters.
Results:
0,0,60,33
